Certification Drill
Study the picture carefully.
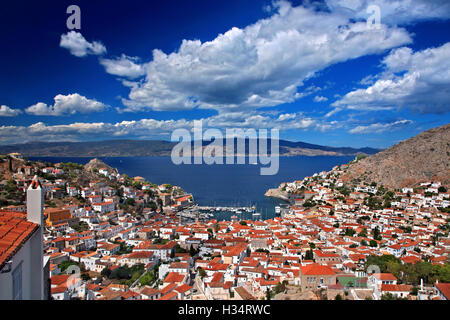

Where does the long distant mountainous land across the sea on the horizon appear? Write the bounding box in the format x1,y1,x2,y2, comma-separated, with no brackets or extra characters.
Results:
0,139,380,157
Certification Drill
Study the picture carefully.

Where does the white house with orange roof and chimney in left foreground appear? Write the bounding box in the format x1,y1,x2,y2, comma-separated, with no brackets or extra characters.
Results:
0,176,50,300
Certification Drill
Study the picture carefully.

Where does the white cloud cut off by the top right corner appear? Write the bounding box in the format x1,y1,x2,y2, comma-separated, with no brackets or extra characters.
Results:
326,0,450,25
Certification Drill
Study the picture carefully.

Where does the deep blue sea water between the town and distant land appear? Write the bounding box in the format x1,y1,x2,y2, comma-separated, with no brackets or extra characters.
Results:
30,156,353,219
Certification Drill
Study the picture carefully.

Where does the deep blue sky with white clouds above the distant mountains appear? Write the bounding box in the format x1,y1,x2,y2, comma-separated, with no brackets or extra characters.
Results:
0,0,450,148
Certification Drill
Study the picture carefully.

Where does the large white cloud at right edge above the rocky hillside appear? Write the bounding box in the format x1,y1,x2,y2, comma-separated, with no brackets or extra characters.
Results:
332,42,450,114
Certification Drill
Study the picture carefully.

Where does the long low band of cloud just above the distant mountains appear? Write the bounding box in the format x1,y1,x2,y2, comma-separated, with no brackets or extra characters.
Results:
0,111,341,145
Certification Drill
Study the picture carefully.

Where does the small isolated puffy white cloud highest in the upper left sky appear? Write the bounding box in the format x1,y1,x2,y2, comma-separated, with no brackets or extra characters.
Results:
59,31,106,57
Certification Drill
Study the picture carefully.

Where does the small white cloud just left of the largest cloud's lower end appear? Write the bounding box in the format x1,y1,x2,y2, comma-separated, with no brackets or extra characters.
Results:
100,54,145,79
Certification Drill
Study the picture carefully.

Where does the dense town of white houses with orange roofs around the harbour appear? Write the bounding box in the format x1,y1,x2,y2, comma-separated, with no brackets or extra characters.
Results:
0,156,450,300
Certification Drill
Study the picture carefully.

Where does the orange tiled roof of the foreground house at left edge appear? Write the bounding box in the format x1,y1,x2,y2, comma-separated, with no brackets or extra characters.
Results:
0,210,39,269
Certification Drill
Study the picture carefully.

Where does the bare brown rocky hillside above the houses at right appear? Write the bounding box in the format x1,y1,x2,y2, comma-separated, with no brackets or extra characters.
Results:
343,124,450,188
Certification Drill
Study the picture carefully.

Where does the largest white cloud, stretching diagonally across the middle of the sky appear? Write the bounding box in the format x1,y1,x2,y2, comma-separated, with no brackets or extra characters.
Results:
117,1,411,111
